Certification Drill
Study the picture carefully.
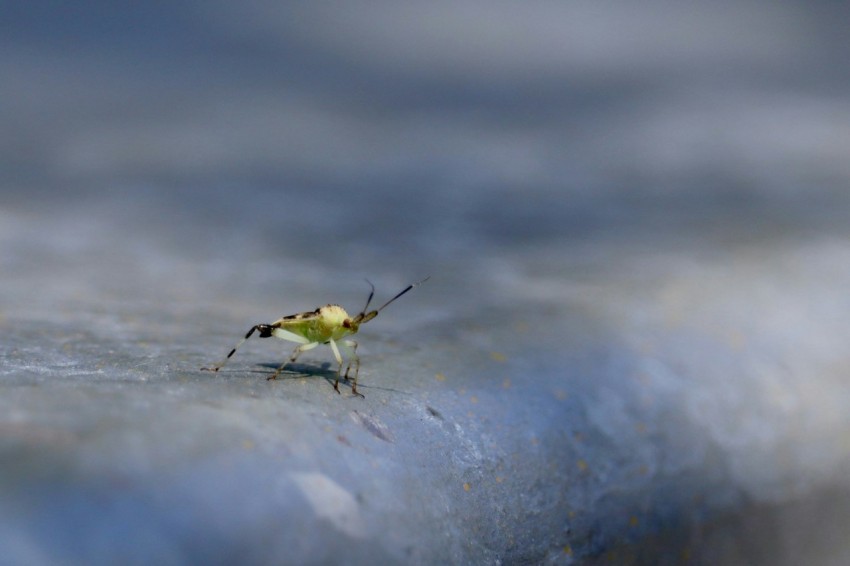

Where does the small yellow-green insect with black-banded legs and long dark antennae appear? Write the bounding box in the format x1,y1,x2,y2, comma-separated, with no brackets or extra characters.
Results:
201,276,430,397
